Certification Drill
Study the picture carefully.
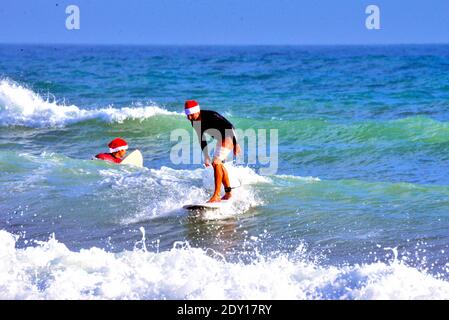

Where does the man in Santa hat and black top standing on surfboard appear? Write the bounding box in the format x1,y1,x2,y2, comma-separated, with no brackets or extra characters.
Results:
184,100,240,203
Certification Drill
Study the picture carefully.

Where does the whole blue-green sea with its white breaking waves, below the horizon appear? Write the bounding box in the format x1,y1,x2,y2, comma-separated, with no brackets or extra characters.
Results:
0,45,449,299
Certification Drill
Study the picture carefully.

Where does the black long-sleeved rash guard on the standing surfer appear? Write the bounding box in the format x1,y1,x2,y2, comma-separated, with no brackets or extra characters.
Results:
190,110,237,151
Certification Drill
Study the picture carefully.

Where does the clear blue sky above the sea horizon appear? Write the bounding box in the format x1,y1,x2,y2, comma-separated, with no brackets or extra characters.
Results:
0,0,449,45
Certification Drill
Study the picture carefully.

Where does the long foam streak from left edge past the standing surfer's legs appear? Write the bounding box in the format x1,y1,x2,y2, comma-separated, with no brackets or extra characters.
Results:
0,152,269,224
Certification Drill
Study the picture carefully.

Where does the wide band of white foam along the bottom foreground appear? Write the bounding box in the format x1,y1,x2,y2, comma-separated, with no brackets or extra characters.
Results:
0,230,449,299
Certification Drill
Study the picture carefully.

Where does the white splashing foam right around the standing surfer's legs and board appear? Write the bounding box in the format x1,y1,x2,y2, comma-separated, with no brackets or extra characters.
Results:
100,165,267,224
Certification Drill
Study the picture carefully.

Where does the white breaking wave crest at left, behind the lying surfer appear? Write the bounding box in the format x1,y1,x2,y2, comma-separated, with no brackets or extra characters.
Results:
0,79,181,127
